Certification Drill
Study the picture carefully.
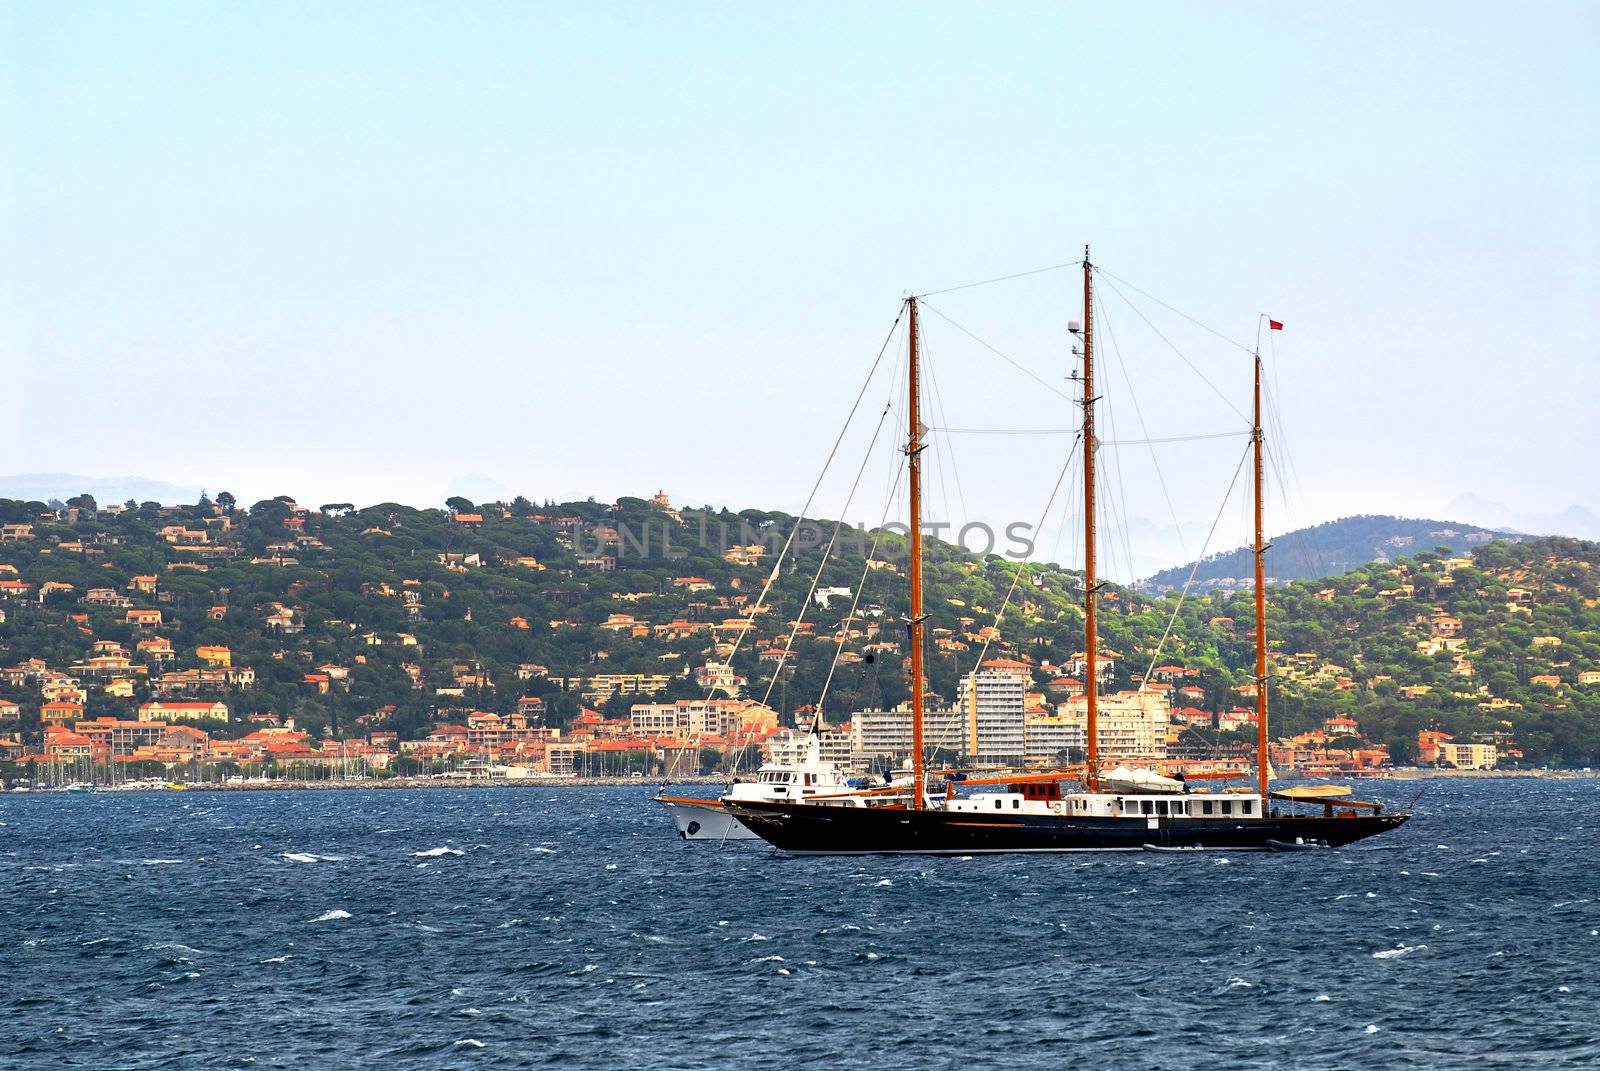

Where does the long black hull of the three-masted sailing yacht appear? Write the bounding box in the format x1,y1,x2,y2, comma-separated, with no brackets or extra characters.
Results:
734,802,1410,855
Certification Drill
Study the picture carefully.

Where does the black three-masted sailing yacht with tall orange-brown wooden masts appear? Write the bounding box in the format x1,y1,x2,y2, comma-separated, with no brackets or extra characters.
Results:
722,250,1410,855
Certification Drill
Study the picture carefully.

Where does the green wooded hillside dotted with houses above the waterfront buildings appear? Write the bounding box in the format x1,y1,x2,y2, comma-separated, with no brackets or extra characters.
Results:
0,495,1600,765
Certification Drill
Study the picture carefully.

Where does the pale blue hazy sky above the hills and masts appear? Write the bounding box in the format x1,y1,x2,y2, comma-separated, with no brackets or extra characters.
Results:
0,2,1600,576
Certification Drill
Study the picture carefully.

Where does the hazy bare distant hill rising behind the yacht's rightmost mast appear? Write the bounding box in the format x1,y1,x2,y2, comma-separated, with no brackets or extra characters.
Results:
1136,515,1530,591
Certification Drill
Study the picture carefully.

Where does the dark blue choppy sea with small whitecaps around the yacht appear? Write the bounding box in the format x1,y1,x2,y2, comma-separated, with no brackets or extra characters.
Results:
0,780,1600,1071
